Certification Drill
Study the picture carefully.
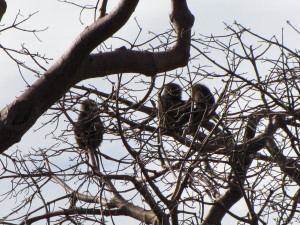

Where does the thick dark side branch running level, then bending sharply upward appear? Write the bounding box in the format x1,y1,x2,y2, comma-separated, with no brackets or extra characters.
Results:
79,0,194,79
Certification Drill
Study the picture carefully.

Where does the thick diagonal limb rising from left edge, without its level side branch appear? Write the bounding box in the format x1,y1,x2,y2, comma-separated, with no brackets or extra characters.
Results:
0,0,138,152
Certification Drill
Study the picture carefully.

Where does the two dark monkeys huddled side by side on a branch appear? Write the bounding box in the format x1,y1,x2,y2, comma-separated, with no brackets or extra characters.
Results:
159,83,218,133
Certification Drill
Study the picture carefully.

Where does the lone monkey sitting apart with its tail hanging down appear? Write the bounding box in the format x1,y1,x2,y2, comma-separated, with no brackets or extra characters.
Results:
74,99,104,169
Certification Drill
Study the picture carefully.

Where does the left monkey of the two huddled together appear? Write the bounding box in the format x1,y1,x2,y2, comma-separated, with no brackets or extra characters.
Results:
158,83,190,131
